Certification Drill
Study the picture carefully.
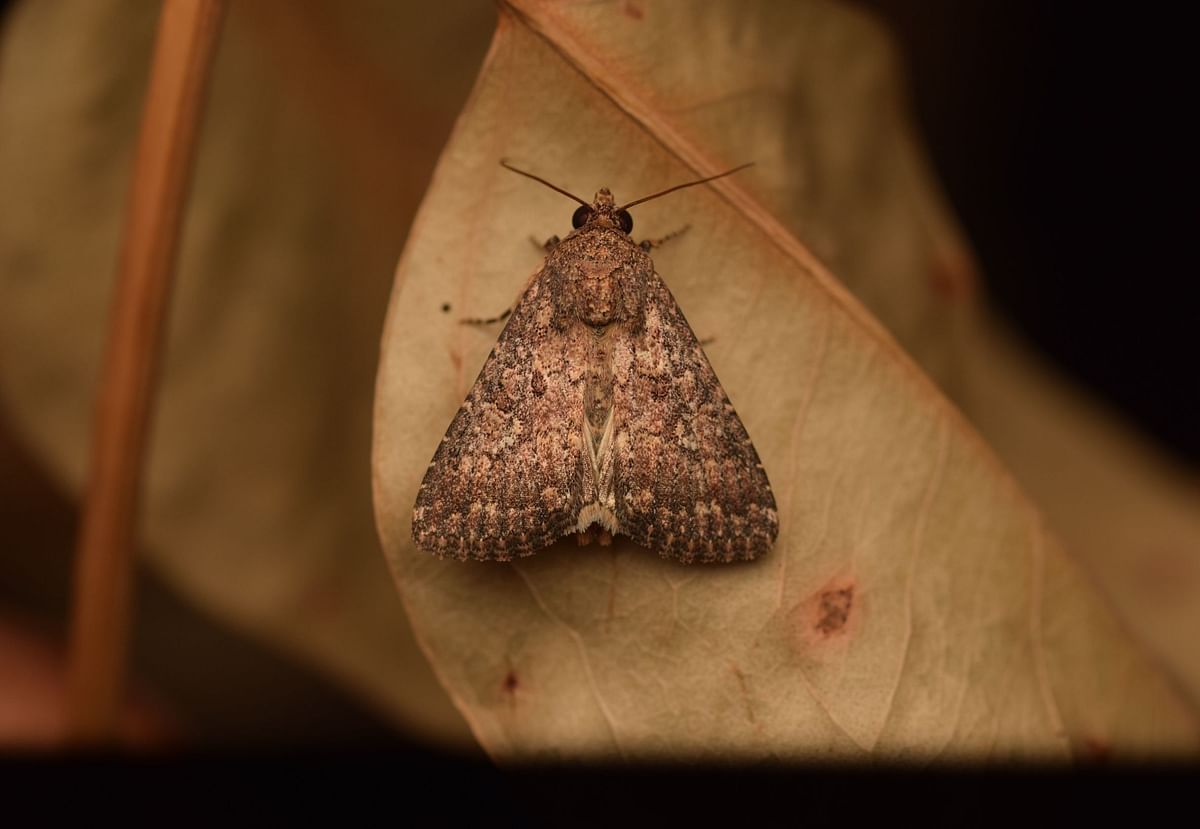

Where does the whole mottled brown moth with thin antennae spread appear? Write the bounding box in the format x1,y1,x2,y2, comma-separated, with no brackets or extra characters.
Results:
413,161,779,563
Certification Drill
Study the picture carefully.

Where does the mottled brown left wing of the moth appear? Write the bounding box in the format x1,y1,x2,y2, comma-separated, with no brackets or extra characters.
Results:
413,270,595,560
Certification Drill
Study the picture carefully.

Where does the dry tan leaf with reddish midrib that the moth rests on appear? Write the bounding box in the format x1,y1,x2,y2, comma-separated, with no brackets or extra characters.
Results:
374,0,1196,758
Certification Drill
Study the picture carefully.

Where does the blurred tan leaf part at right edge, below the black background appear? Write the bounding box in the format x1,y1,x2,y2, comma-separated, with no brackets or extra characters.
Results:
956,320,1200,705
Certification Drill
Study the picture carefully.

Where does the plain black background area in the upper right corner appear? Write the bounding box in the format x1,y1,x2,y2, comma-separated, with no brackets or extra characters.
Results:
862,0,1200,468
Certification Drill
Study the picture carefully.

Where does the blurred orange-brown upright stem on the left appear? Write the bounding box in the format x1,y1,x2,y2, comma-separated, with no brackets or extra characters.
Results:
67,0,224,745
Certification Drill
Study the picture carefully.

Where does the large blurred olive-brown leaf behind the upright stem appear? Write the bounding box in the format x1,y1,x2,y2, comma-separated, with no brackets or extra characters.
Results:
0,0,494,746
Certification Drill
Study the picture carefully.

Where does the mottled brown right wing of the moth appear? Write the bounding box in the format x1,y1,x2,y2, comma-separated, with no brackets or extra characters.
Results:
612,274,779,563
